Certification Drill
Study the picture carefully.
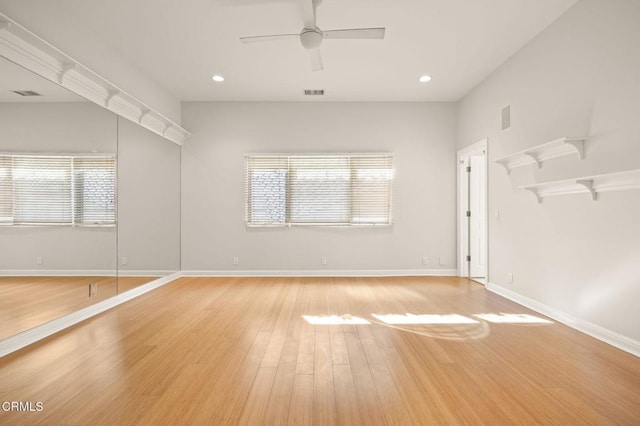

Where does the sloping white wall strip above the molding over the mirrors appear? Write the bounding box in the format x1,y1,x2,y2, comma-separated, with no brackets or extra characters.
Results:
0,0,180,123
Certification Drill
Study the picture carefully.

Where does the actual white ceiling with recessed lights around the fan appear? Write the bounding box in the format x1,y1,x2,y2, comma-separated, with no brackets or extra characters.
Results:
2,0,576,101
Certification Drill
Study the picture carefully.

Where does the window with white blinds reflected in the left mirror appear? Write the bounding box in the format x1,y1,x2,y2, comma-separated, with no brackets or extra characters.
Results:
0,154,116,226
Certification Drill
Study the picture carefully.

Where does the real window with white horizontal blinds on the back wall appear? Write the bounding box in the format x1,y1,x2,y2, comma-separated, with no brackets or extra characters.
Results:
245,154,393,226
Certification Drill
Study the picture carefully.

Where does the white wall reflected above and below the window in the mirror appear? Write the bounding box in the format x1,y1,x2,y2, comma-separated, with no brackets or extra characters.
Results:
0,102,117,270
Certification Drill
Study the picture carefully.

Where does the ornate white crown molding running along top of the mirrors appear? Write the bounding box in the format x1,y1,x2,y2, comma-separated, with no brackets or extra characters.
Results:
0,13,191,145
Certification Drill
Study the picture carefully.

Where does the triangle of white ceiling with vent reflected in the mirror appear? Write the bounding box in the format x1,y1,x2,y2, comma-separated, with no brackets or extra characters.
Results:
0,58,86,102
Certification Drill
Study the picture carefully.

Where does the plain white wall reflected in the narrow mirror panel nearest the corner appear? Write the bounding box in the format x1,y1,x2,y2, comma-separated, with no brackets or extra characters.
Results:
118,118,180,275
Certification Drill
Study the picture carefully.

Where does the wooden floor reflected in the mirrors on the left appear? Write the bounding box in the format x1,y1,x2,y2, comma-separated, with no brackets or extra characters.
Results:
0,276,157,339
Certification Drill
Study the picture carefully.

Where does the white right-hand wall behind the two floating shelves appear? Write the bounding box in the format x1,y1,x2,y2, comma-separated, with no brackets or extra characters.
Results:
457,0,640,341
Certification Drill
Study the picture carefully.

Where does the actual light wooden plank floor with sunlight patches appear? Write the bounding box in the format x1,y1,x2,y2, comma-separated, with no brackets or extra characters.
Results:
0,277,640,425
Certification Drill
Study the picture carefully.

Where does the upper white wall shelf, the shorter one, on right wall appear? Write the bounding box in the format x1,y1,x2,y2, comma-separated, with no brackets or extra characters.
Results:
494,137,586,174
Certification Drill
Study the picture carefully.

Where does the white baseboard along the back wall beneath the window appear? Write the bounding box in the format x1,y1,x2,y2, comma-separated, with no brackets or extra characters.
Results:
182,269,457,277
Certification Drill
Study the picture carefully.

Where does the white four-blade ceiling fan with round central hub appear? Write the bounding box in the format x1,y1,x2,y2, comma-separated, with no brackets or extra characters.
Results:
240,0,385,71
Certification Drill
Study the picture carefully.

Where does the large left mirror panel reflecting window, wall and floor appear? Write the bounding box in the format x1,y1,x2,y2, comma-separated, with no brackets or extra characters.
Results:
0,58,118,339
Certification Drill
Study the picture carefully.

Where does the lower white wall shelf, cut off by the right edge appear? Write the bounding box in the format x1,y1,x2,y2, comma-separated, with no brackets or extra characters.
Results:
519,169,640,203
